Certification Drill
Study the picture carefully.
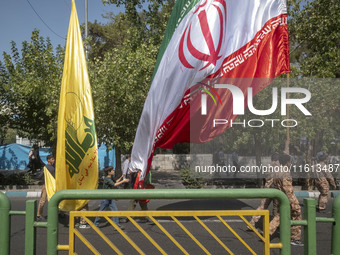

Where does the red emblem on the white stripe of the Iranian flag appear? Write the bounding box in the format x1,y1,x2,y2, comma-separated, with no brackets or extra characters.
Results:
178,0,227,71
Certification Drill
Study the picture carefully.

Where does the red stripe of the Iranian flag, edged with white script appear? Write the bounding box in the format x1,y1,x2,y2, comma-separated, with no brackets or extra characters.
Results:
146,14,290,174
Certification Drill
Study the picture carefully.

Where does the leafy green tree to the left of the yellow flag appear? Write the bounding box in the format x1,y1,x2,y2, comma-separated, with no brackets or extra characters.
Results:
0,30,63,144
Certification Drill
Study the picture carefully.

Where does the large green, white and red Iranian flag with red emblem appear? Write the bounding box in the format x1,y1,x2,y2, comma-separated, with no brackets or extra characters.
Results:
131,0,290,183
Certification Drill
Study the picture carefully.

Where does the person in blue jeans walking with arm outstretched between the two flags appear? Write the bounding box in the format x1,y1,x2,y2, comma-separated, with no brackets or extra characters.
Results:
94,166,130,229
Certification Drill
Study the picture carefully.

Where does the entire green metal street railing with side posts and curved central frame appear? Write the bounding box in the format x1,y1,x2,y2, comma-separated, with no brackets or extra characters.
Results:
0,189,340,255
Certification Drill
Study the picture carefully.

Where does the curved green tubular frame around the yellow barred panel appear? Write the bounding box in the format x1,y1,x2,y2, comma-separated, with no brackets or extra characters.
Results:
47,189,291,255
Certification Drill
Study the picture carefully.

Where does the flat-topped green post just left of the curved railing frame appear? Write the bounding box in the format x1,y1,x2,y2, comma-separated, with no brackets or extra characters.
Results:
25,200,37,255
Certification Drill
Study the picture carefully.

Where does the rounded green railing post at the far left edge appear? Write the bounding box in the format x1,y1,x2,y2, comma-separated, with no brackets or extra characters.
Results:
0,192,11,255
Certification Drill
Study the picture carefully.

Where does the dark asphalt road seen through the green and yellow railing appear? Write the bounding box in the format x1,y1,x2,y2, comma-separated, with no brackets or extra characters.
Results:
10,198,333,255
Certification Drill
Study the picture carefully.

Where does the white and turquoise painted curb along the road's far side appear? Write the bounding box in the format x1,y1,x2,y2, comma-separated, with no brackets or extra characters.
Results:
1,191,340,198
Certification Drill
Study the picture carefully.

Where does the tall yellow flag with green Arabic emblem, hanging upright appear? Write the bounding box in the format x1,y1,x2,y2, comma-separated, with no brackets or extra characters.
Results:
55,0,98,211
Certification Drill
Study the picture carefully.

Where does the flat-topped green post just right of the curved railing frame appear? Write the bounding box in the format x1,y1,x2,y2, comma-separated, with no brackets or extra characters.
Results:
303,198,317,255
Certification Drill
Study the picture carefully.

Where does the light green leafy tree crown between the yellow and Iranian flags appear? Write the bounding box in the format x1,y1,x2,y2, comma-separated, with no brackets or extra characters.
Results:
89,42,158,153
